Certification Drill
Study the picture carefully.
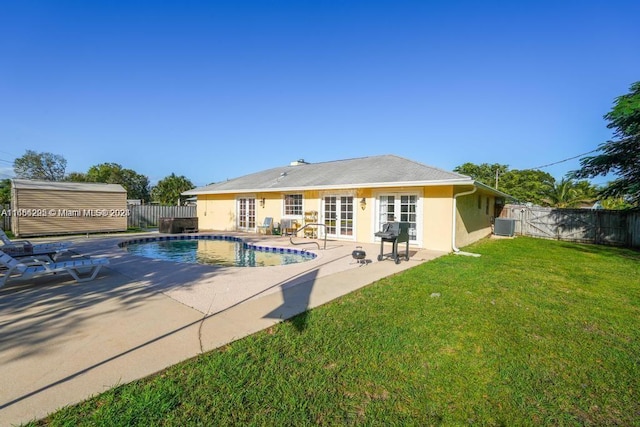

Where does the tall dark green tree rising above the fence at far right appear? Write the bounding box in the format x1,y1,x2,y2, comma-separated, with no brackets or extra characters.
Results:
570,81,640,207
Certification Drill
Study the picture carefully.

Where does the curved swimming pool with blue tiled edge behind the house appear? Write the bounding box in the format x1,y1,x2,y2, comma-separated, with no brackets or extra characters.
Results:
118,235,316,267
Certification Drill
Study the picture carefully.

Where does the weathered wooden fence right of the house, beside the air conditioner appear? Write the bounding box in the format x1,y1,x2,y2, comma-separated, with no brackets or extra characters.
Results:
500,205,640,248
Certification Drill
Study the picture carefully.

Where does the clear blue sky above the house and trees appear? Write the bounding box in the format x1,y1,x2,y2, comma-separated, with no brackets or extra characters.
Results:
0,0,640,185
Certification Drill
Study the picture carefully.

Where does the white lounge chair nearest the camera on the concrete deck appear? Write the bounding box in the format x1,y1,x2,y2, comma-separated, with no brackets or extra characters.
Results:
0,252,109,288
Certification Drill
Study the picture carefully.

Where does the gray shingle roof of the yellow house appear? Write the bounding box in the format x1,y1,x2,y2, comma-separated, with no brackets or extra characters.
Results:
182,155,473,195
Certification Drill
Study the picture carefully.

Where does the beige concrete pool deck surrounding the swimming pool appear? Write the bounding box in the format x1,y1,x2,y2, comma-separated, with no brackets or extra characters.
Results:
0,232,444,426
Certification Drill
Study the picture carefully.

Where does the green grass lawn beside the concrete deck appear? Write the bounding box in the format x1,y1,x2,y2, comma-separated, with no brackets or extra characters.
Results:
27,237,640,426
